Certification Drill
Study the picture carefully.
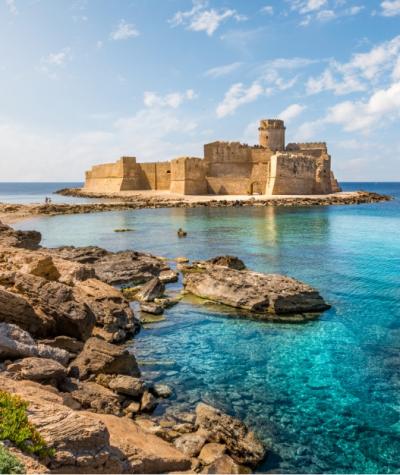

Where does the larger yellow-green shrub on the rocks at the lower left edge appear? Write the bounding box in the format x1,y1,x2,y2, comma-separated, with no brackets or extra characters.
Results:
0,391,54,458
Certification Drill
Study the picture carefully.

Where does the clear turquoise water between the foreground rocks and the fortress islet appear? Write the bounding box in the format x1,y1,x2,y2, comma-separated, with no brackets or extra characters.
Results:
14,183,400,473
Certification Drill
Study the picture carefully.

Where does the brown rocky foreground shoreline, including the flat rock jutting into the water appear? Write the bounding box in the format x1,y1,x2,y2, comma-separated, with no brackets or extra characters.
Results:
0,212,336,473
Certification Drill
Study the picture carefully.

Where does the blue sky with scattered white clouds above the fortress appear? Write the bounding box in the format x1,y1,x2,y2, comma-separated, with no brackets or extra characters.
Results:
0,0,400,181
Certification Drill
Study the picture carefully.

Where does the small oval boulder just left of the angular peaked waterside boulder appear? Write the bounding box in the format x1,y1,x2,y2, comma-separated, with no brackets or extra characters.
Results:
7,356,67,383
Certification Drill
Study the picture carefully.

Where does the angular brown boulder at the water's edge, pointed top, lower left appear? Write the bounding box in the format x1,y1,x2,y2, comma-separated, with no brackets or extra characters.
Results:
70,337,140,380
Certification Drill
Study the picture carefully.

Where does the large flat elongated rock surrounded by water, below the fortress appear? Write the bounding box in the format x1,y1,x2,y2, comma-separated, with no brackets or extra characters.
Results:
184,263,329,318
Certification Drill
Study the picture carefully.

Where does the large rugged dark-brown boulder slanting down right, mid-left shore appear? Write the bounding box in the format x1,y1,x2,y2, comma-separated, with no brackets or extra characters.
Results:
15,273,96,340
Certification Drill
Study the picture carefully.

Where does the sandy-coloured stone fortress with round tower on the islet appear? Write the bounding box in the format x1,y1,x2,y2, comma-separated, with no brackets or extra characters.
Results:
84,119,340,195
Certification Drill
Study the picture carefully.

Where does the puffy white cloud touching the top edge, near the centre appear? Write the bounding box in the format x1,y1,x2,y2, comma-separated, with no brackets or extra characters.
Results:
169,0,246,36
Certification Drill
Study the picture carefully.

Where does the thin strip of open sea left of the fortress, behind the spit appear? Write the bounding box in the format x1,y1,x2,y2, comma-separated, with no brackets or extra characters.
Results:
0,182,88,203
